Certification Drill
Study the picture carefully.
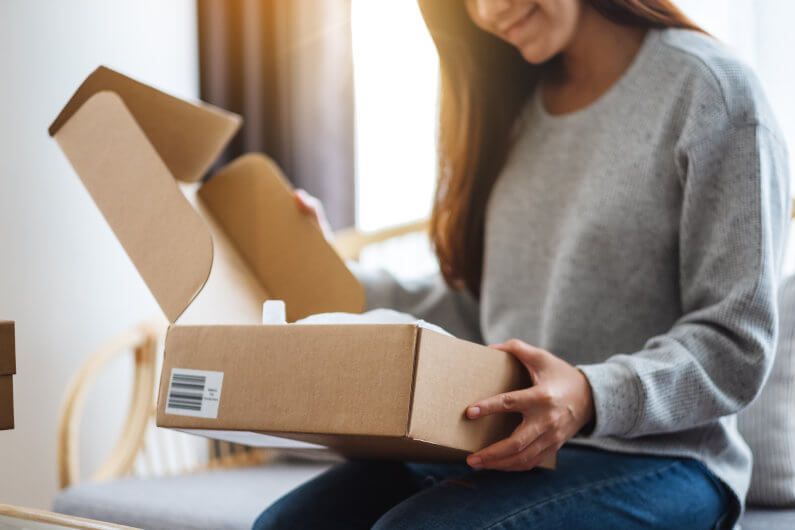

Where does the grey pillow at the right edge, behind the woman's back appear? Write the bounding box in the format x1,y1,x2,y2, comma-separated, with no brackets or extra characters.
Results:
738,276,795,507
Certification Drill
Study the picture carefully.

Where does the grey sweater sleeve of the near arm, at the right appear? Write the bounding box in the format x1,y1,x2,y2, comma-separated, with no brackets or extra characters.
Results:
579,124,789,438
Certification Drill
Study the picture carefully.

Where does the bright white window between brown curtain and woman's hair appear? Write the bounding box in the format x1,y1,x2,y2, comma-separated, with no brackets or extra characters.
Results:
351,0,439,230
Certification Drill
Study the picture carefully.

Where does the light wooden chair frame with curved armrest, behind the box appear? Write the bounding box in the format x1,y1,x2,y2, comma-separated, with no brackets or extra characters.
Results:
56,221,428,489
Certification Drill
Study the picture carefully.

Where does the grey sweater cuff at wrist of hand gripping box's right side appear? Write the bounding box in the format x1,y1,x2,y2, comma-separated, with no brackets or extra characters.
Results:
577,361,641,438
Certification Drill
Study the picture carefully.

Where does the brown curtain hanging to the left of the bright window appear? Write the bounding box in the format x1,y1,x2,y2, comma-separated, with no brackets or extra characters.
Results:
197,0,355,228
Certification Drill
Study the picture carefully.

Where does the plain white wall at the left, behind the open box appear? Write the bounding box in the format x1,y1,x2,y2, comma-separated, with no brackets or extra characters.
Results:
0,0,198,508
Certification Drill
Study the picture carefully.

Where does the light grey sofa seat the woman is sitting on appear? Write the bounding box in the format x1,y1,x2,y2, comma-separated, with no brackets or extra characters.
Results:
54,462,795,530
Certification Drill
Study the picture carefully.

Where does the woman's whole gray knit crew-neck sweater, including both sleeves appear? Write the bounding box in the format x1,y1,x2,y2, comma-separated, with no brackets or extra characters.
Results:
356,30,789,520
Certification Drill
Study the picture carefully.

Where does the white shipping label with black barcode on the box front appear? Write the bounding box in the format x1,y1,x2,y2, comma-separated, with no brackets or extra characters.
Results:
166,368,224,418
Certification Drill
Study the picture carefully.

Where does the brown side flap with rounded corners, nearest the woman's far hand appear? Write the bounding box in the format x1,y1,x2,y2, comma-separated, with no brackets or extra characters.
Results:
199,154,365,322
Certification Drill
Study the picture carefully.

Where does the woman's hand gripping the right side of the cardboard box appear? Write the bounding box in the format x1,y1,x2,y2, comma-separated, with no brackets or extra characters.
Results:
467,339,594,471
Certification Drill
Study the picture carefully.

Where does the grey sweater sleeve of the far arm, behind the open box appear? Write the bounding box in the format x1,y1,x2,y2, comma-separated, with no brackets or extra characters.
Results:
348,261,483,343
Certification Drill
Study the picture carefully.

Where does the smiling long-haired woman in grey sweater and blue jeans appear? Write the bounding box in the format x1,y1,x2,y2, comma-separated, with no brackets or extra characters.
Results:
255,0,789,528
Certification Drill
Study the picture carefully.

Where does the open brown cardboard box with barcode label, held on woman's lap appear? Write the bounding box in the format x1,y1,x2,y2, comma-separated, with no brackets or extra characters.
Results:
50,67,554,466
